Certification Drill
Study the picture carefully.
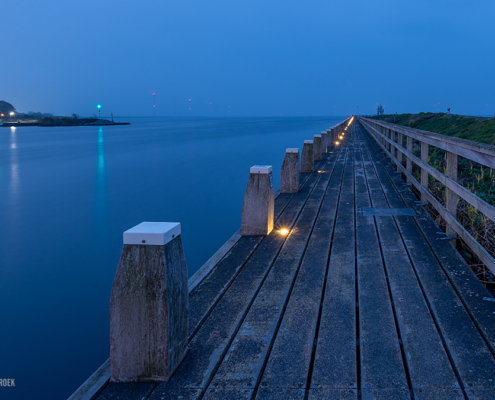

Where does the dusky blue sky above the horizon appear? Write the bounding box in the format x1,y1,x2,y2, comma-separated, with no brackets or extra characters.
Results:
0,0,495,116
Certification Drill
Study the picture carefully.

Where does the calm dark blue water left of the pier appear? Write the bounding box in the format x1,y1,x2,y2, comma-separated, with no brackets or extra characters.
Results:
0,117,343,399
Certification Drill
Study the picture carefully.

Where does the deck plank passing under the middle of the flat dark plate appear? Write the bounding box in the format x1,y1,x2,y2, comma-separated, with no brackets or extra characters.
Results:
363,136,457,388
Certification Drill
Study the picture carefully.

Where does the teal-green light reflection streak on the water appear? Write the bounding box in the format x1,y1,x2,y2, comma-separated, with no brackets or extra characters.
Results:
95,126,108,242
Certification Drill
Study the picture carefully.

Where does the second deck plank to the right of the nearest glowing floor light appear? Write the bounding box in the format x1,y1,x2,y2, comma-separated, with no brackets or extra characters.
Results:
261,149,344,388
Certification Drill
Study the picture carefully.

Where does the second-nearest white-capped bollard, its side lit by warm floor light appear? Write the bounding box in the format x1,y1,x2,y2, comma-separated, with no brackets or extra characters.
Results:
241,165,275,236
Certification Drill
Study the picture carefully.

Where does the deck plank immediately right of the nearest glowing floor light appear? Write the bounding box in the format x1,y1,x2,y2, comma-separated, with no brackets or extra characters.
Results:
210,148,346,390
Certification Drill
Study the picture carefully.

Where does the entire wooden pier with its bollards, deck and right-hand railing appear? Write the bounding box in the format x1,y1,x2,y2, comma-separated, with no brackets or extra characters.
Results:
71,117,495,400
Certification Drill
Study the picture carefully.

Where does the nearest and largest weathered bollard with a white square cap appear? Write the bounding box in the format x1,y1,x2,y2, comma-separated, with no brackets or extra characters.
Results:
110,222,189,382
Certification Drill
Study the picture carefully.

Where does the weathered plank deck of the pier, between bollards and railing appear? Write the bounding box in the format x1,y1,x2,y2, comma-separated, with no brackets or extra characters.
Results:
92,123,495,400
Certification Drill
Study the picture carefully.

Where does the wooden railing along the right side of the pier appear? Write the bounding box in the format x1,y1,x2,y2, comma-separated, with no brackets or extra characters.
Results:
358,117,495,274
